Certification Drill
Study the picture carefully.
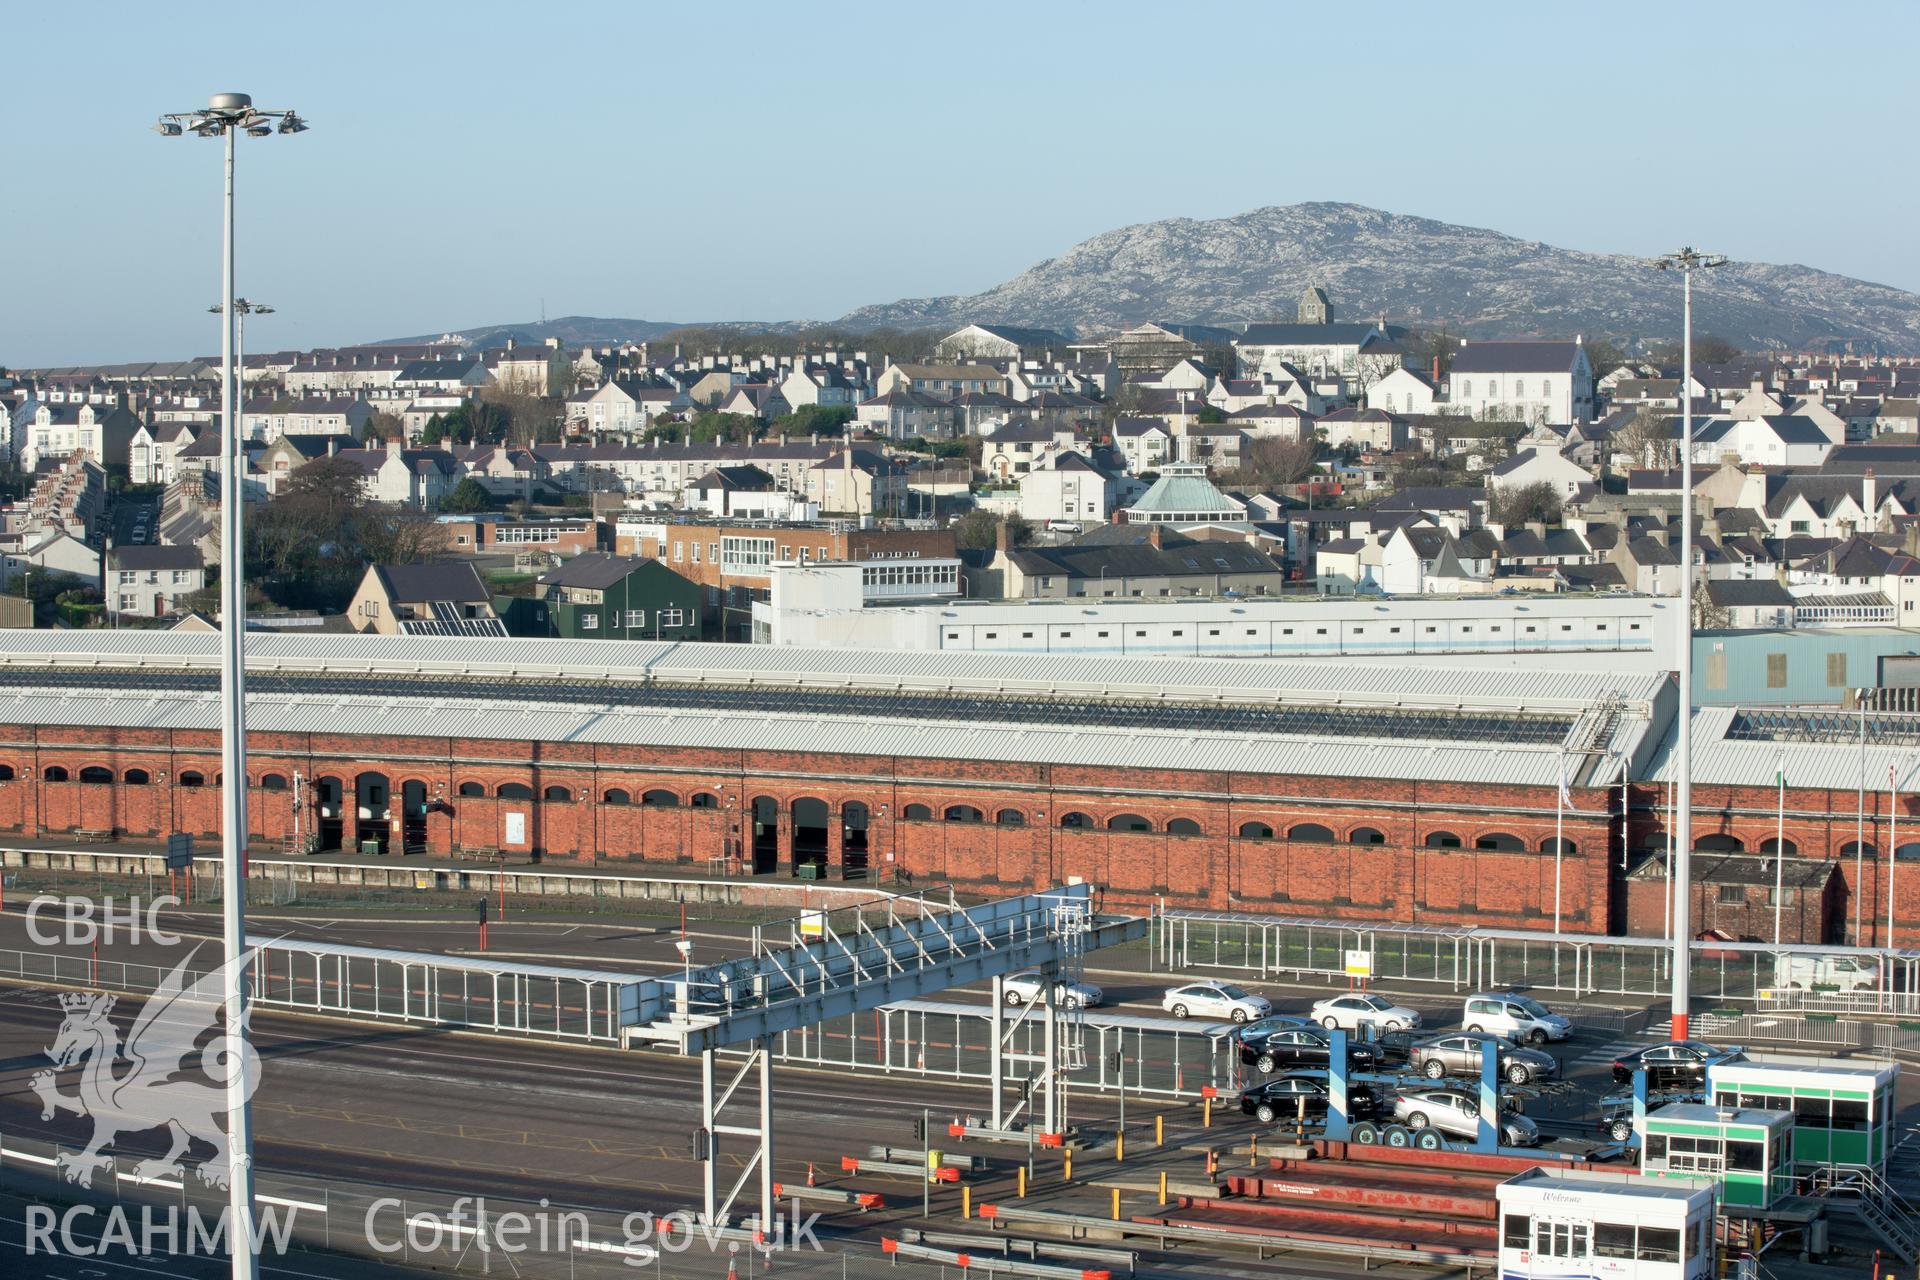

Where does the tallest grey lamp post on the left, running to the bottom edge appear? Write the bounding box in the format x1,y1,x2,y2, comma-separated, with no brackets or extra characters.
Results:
154,94,307,1280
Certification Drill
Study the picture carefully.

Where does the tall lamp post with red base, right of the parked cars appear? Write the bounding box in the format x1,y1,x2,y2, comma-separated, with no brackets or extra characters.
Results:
1653,246,1726,1040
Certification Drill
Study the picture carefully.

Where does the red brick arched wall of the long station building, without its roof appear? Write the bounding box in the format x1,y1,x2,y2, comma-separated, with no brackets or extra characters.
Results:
0,727,1628,933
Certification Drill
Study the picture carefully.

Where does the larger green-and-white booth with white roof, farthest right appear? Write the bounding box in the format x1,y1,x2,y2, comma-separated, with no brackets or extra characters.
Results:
1707,1055,1901,1173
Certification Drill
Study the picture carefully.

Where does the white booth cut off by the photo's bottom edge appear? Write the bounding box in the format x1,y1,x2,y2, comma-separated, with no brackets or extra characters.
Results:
1496,1169,1715,1280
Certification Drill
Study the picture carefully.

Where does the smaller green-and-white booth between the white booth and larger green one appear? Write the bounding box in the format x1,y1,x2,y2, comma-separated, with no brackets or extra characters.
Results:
1640,1102,1793,1209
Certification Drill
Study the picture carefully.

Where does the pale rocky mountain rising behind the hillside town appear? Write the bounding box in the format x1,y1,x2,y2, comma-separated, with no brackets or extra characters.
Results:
841,203,1920,353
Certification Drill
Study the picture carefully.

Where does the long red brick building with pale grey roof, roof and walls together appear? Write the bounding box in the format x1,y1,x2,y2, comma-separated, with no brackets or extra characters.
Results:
0,633,1674,933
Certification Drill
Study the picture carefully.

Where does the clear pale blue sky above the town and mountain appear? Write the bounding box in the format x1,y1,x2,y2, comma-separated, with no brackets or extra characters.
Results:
0,0,1920,368
